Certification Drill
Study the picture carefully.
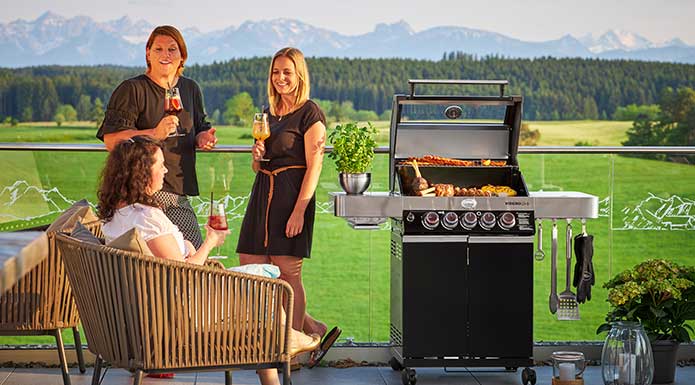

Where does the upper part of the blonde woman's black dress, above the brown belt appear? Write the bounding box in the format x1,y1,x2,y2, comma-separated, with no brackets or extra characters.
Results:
261,100,326,170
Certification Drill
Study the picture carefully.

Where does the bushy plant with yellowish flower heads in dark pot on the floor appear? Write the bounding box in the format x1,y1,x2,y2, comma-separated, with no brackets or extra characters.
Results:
596,259,695,384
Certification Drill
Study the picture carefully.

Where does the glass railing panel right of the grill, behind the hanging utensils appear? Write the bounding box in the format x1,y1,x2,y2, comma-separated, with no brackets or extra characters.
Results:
510,154,613,341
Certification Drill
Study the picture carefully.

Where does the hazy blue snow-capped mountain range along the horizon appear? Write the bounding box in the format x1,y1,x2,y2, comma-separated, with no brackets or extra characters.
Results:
0,12,695,67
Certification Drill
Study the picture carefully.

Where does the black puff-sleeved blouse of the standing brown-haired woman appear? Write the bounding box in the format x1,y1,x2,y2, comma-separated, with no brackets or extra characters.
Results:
97,75,211,195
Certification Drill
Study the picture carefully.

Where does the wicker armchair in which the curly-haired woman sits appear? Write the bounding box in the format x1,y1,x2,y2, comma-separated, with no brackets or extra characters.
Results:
57,234,293,385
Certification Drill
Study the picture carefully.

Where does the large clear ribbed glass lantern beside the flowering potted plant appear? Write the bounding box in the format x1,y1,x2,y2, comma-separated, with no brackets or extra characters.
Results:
601,321,654,385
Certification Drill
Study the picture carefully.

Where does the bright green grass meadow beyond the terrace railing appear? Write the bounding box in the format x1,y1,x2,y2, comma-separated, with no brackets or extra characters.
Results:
0,121,695,344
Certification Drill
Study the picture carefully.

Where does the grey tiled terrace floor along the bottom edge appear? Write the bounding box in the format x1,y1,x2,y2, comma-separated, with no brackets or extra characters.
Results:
0,366,695,385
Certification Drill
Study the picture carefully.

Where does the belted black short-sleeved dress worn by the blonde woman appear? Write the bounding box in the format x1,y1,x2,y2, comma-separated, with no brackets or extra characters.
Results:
236,100,326,258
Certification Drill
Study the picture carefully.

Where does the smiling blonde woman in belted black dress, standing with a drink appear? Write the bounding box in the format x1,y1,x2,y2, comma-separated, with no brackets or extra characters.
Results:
237,48,340,365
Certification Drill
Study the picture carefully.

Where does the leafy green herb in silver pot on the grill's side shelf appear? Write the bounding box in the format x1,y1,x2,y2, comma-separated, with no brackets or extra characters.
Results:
328,122,376,194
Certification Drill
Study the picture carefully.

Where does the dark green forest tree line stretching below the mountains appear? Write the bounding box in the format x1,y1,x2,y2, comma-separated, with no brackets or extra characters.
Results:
0,52,695,121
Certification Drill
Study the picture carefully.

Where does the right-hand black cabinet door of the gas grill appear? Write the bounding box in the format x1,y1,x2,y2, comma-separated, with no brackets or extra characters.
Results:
468,237,533,358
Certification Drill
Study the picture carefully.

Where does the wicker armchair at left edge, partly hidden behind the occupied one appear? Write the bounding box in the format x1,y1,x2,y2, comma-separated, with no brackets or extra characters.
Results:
0,221,101,385
